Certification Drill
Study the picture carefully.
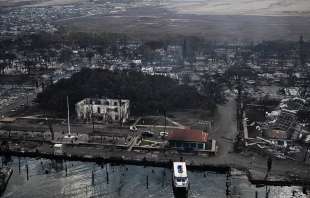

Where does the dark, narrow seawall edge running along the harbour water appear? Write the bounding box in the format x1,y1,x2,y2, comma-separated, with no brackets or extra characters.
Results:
0,151,310,188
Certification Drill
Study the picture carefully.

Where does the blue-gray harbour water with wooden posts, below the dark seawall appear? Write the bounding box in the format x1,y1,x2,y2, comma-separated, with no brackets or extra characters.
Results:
3,158,306,198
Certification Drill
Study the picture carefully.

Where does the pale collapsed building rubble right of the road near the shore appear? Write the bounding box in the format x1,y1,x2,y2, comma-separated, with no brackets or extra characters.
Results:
245,97,310,160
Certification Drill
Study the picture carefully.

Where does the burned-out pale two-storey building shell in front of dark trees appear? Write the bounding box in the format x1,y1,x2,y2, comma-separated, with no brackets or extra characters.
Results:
75,98,129,123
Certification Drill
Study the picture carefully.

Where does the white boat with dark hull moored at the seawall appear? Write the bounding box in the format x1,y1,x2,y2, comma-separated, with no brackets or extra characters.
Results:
172,162,189,197
